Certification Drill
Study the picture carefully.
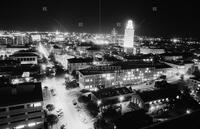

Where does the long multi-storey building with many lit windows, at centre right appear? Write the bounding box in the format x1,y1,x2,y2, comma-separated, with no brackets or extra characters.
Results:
79,61,171,90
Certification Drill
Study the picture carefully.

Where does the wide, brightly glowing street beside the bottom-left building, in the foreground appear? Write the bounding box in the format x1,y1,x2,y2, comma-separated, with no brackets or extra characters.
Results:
42,76,93,129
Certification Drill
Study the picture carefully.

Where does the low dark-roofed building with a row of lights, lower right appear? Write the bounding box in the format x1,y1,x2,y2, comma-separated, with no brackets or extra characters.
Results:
137,86,182,114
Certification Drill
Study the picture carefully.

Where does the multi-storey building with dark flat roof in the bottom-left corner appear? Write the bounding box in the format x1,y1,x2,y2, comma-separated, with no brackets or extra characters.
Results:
0,83,44,129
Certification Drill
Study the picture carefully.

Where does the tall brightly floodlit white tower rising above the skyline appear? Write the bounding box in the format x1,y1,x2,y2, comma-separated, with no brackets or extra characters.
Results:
124,20,136,54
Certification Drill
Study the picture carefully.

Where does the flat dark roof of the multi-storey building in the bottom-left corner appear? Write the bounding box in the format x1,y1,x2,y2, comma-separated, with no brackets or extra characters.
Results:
0,83,43,107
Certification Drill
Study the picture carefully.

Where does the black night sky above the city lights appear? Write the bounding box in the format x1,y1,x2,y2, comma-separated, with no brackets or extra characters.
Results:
0,0,200,38
